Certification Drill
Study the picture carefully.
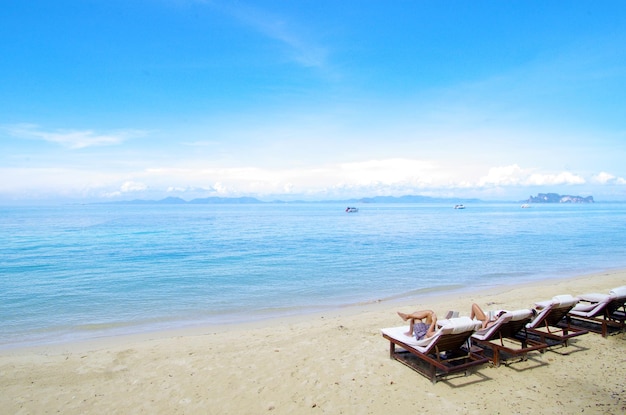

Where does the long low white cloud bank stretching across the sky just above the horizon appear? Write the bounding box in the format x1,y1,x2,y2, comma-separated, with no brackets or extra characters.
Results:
0,158,626,203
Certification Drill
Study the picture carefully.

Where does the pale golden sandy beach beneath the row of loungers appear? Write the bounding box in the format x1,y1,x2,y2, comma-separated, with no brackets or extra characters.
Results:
0,270,626,414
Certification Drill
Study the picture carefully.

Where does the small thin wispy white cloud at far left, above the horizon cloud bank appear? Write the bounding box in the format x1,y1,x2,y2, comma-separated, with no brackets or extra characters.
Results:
4,124,145,150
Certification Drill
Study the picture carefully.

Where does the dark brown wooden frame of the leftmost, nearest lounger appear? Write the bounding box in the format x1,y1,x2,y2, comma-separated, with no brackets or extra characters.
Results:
383,331,489,384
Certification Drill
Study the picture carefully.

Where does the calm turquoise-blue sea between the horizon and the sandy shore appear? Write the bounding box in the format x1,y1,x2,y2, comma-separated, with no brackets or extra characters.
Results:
0,203,626,348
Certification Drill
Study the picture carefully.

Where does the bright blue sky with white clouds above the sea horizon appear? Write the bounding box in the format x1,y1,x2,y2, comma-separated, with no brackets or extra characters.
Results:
0,0,626,202
